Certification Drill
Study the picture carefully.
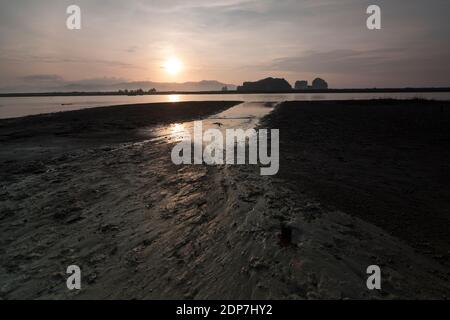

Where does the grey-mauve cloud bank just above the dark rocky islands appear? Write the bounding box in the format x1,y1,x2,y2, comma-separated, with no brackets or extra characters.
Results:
264,48,450,87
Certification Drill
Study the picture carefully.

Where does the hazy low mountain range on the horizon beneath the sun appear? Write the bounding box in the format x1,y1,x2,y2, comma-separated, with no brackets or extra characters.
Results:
0,79,236,93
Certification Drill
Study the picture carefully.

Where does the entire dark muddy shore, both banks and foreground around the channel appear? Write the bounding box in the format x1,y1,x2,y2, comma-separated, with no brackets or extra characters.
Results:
0,100,450,299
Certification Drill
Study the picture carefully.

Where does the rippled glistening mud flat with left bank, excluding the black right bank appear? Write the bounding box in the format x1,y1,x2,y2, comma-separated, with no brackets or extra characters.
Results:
0,101,450,299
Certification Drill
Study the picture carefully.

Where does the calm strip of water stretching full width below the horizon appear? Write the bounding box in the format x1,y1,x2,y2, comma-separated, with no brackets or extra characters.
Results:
0,92,450,119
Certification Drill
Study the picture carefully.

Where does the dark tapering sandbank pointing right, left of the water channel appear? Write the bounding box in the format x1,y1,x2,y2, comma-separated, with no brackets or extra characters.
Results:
0,101,239,163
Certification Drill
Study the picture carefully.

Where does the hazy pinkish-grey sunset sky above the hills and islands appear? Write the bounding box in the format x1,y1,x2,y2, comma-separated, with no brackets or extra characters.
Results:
0,0,450,88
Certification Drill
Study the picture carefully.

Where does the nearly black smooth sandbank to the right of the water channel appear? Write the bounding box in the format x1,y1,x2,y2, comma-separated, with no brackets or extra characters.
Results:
266,100,450,267
